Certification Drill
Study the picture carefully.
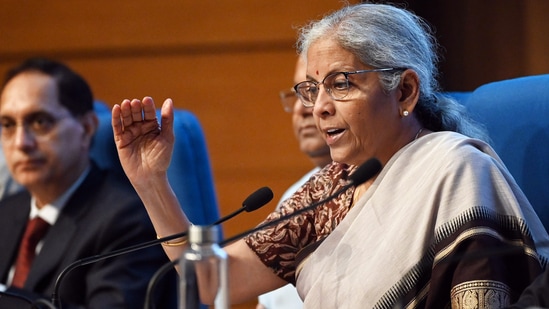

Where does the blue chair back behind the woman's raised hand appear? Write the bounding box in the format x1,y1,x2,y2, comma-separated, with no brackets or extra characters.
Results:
90,101,219,225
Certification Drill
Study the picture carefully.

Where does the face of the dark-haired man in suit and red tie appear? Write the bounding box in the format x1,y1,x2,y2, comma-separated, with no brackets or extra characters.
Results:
0,72,90,192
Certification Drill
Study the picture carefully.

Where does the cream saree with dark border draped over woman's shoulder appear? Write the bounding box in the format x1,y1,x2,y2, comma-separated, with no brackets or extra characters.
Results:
247,132,549,309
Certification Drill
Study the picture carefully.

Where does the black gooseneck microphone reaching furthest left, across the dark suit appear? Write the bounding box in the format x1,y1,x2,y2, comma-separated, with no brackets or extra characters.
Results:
51,187,273,308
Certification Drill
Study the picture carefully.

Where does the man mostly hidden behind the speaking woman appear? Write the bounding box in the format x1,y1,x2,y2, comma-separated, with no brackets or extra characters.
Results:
257,57,332,309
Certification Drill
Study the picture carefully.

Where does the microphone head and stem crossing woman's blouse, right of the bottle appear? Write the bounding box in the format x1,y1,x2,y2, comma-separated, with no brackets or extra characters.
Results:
219,158,382,247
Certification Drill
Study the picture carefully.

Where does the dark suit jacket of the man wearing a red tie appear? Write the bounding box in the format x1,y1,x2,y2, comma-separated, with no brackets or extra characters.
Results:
0,165,177,309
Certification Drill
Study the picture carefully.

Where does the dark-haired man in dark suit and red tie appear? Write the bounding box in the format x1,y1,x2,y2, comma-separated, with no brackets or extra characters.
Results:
0,59,177,308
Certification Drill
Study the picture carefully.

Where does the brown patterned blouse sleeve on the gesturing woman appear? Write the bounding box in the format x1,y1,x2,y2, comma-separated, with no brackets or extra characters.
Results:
244,162,356,284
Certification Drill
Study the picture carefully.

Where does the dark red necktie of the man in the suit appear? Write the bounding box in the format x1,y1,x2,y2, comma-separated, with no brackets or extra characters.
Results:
12,217,50,288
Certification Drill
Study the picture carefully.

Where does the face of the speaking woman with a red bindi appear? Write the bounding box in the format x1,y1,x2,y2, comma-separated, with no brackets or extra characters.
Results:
307,40,409,165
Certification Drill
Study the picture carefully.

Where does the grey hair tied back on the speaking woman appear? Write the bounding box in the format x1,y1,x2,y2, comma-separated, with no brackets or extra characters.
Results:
297,3,489,141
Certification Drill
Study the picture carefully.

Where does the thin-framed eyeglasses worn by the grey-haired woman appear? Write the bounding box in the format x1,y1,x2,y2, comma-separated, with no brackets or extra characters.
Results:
294,68,406,107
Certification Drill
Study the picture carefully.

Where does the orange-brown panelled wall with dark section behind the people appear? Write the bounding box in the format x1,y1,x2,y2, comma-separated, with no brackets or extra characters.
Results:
0,0,549,308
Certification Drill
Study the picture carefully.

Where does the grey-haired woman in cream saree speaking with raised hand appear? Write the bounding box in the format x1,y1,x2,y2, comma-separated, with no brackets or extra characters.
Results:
113,4,548,309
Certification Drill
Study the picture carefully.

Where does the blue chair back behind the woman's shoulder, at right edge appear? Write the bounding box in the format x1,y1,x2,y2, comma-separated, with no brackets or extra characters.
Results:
456,74,549,231
